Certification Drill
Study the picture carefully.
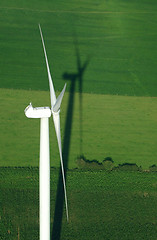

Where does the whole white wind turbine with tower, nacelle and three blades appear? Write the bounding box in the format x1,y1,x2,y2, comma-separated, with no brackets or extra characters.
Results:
25,25,69,240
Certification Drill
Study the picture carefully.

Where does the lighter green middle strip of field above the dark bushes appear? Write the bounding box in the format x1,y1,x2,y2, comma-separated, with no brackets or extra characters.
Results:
0,89,157,169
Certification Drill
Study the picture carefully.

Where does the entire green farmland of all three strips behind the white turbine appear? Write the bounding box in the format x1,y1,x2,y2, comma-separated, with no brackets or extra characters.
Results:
0,0,157,240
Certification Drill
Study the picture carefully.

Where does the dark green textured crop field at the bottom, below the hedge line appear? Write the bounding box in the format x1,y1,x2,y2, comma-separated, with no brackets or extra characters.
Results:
0,168,157,240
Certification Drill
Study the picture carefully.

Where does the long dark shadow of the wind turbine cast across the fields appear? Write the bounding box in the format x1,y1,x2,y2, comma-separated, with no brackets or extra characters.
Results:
51,38,89,240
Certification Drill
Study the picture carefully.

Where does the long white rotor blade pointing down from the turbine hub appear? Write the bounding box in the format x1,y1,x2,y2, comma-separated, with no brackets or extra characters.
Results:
53,112,69,222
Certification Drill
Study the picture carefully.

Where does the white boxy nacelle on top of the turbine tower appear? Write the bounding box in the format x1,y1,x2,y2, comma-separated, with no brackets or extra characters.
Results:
24,103,51,118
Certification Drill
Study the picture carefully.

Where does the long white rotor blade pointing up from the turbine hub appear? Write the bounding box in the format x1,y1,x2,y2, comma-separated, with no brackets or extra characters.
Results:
39,24,56,108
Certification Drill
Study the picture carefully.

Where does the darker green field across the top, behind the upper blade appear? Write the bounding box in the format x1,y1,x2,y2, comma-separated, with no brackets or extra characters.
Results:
0,0,157,96
